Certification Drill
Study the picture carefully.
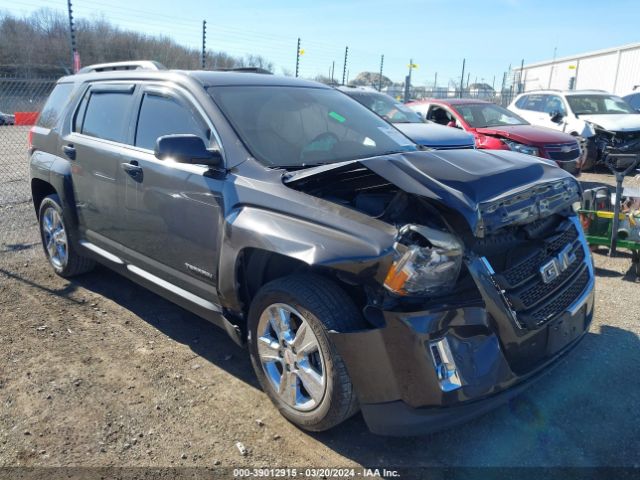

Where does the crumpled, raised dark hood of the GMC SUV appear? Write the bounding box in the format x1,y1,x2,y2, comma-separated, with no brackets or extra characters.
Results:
284,150,580,237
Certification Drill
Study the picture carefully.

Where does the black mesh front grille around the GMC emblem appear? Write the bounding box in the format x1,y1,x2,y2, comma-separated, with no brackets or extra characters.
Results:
494,222,589,329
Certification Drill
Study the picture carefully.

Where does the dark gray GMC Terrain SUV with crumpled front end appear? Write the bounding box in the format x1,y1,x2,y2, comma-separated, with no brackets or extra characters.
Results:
30,64,594,435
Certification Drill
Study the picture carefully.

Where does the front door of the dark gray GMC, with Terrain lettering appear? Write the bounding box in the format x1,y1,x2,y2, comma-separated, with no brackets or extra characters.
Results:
120,85,224,301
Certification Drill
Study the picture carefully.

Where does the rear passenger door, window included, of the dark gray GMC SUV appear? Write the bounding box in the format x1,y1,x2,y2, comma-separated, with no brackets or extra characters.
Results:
62,83,136,246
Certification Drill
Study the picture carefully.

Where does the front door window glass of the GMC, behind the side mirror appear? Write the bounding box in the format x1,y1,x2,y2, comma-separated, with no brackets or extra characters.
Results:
135,93,210,150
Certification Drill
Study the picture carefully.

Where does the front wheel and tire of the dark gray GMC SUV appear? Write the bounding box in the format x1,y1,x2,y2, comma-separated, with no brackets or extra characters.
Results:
249,274,364,431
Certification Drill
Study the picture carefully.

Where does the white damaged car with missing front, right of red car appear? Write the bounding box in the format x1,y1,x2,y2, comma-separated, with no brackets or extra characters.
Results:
509,90,640,170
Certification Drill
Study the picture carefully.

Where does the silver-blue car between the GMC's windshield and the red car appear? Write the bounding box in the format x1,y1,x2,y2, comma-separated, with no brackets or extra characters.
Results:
338,87,475,150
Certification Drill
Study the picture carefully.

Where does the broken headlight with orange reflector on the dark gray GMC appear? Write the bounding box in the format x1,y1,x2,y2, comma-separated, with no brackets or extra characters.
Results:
384,225,463,295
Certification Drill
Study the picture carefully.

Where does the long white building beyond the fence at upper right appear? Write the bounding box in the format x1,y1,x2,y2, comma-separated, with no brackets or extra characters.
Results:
513,43,640,95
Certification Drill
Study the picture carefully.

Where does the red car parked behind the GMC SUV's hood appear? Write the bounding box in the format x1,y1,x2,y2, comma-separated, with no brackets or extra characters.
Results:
407,98,582,175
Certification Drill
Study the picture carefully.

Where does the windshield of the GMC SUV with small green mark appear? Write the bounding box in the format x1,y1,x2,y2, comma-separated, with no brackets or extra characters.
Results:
208,86,417,168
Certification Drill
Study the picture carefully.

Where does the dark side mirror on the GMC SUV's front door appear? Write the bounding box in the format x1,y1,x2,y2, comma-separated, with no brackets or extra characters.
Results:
154,134,222,167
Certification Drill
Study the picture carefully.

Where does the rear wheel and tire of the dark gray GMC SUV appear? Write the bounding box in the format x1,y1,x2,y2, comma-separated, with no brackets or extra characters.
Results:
38,194,95,278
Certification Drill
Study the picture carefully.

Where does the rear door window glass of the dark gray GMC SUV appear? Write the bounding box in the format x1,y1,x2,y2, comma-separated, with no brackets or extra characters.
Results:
77,91,133,143
